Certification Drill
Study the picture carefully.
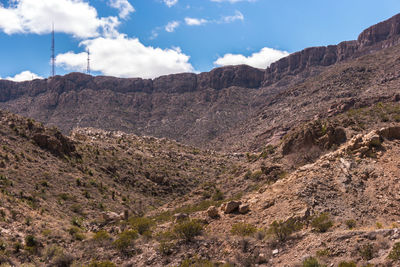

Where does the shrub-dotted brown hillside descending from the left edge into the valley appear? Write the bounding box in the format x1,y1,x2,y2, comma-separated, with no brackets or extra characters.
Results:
0,111,260,266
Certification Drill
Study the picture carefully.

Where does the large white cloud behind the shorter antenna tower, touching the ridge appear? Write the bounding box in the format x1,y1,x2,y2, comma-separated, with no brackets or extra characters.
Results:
56,34,194,78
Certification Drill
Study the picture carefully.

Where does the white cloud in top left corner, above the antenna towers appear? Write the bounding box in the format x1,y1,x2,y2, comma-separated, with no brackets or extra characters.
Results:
0,0,119,39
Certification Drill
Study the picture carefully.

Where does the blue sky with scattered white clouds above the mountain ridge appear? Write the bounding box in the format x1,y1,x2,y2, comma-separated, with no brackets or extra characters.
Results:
0,0,400,81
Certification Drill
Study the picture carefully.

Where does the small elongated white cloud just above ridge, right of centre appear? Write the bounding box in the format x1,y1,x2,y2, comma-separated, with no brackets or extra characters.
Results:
214,47,289,69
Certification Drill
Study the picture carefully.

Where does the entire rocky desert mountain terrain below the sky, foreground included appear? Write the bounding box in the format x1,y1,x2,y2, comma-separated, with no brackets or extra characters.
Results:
0,15,400,267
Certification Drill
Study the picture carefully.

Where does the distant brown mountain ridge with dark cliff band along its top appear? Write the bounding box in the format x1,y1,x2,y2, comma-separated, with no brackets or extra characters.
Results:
0,14,400,151
